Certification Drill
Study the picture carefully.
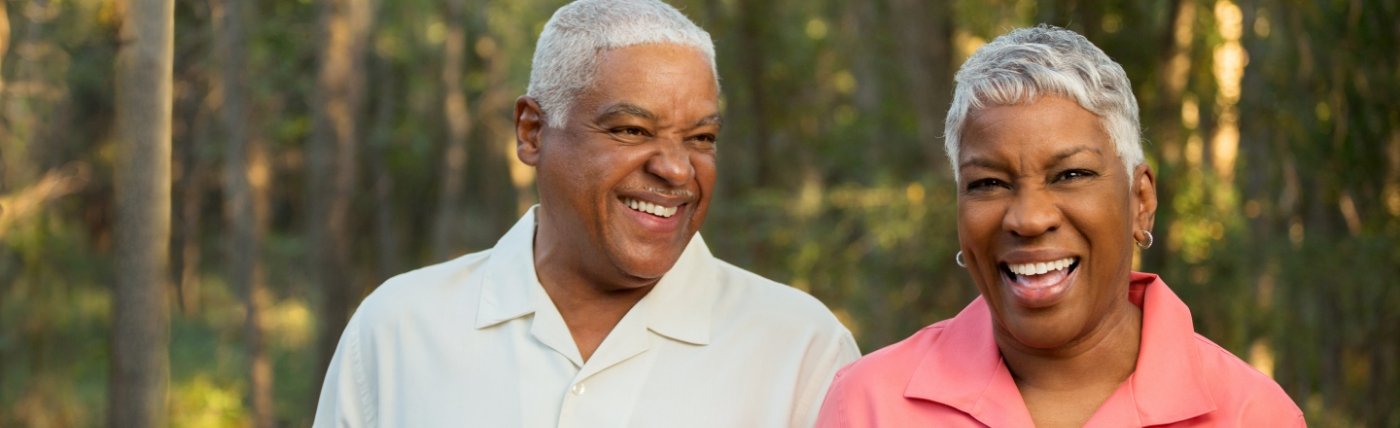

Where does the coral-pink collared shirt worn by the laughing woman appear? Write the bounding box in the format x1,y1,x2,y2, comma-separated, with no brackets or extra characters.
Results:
816,273,1305,428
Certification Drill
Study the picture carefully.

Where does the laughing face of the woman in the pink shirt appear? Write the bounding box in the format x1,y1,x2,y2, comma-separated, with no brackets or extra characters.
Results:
958,97,1156,350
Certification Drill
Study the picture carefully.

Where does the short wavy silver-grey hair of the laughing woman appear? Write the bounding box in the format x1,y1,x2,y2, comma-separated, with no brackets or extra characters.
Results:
944,24,1142,181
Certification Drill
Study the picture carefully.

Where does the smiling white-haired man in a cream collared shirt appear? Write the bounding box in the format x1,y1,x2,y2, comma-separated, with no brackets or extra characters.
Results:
315,0,858,427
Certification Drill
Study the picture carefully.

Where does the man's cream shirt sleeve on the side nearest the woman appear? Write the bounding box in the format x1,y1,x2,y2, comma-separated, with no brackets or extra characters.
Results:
792,327,861,427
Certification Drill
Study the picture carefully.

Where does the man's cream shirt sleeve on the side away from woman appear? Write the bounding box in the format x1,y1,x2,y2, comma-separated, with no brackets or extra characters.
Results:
312,316,374,428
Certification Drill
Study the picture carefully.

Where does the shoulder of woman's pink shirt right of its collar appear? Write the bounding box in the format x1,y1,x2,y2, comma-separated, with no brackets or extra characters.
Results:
1196,334,1302,420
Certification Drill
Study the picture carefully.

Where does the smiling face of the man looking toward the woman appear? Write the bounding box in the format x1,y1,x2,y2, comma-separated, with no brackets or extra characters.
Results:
522,43,720,288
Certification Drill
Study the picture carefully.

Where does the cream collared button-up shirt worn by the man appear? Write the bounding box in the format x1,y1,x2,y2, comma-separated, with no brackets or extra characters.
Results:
315,208,860,427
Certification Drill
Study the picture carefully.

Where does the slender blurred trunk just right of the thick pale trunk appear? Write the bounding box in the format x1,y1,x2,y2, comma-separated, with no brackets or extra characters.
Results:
211,0,276,428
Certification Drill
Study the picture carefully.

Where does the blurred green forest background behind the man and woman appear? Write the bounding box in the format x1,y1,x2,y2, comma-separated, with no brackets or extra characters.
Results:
0,0,1400,427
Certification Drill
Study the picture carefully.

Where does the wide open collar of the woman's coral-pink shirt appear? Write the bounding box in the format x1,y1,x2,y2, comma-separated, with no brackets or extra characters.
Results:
904,273,1217,427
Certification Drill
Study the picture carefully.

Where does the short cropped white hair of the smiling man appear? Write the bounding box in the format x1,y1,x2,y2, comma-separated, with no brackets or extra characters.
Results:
525,0,720,127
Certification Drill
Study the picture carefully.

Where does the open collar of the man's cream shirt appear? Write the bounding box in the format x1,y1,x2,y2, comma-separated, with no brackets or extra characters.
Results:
476,206,721,345
